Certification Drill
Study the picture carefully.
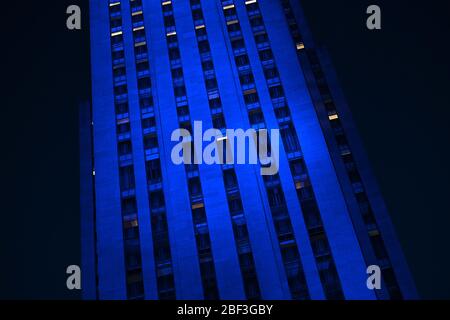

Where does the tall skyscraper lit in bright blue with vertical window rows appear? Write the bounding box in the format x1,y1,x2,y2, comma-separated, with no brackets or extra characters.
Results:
82,0,416,299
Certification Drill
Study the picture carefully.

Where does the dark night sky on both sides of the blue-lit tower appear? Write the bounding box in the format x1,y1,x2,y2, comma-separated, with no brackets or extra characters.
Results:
0,0,450,299
